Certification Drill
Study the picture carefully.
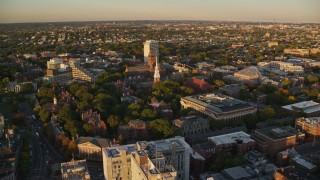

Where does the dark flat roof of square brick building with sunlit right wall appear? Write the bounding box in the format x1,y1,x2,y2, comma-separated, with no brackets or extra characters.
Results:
256,127,295,140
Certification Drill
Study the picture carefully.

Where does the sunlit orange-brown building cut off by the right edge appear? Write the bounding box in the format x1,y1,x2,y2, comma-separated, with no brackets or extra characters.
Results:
296,117,320,136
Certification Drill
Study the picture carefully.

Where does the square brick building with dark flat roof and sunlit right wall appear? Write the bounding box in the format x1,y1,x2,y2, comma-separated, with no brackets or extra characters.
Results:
252,127,297,157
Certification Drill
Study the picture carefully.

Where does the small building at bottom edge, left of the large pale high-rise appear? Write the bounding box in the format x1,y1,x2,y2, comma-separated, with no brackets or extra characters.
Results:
61,160,91,180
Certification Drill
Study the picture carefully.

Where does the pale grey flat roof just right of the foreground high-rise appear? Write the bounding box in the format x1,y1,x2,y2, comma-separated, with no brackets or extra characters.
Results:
208,131,254,145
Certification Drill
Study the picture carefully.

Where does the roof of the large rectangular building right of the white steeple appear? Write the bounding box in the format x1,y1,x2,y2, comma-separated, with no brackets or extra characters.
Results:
182,93,253,112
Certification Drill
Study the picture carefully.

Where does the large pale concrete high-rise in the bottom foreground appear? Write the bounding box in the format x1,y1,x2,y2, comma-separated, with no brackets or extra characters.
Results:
102,137,191,180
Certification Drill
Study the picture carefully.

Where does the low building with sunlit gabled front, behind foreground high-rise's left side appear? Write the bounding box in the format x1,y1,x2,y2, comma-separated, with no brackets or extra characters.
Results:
76,137,110,161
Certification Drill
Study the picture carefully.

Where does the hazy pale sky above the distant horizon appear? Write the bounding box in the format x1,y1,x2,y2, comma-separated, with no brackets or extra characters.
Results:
0,0,320,23
